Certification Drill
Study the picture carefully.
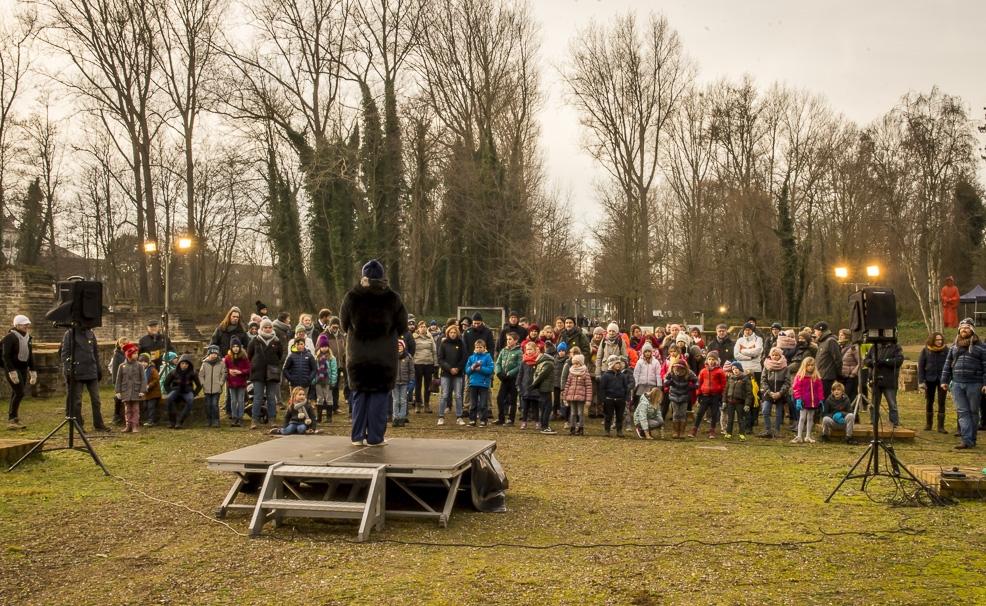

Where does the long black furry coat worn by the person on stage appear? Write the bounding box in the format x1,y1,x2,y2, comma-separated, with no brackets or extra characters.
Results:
339,280,407,392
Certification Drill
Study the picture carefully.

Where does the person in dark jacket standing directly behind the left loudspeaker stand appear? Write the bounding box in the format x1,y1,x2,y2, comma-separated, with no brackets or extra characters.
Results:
58,326,109,431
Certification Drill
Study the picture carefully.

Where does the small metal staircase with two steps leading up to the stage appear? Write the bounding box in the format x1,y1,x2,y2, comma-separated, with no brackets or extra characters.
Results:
250,463,386,541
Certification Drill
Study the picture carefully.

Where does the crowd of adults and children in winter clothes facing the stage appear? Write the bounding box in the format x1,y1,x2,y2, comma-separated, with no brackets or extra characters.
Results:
2,299,986,448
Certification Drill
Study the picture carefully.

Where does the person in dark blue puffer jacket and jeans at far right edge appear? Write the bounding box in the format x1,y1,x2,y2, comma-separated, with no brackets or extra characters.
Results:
939,318,986,450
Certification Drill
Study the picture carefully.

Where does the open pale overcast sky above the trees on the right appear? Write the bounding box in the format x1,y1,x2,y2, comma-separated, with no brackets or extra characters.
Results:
530,0,986,228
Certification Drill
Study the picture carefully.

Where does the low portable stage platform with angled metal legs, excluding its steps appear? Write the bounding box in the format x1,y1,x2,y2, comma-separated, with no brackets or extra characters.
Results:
206,435,496,527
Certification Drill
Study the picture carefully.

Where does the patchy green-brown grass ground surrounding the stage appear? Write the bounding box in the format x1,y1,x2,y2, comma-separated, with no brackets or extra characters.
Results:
0,384,986,605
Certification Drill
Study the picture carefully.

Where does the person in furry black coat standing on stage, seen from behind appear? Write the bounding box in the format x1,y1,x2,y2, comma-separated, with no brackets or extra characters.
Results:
340,259,407,446
